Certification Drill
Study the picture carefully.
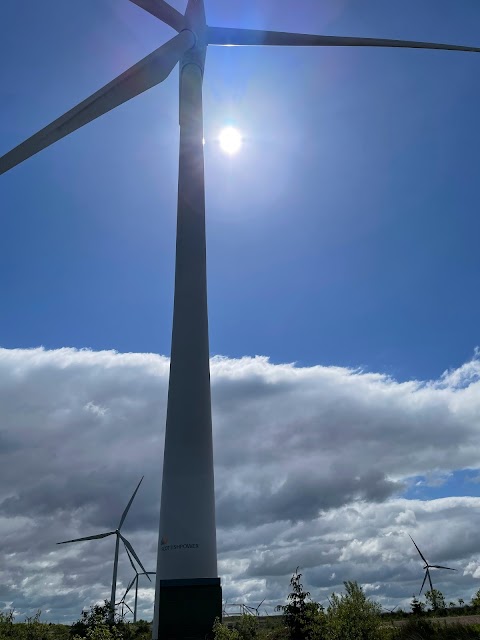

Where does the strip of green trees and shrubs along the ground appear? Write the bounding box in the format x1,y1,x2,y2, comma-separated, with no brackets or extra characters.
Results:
4,568,480,640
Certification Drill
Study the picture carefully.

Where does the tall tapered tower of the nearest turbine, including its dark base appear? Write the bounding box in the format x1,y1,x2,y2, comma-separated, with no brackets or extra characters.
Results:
153,2,222,638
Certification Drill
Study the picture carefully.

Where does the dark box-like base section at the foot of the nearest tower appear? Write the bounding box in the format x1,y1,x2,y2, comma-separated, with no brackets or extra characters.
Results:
158,578,222,640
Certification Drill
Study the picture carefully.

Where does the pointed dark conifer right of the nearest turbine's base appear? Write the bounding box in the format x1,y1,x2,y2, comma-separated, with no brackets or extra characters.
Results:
276,567,325,640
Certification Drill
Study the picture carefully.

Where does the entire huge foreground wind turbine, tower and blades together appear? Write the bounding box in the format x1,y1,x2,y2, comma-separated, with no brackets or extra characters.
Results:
0,0,480,640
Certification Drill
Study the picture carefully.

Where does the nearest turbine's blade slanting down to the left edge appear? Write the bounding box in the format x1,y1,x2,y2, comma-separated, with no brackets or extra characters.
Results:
0,31,194,174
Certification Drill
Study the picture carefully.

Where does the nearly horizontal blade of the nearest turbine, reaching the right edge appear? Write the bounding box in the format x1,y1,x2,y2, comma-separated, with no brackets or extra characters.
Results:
207,27,480,53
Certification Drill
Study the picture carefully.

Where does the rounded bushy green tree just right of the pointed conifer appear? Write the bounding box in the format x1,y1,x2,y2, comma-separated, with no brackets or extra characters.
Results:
327,581,381,640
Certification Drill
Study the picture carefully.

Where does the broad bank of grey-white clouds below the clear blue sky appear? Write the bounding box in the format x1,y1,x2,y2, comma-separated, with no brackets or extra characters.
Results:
0,348,480,621
